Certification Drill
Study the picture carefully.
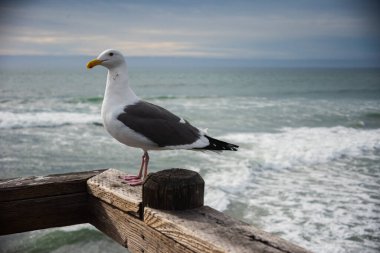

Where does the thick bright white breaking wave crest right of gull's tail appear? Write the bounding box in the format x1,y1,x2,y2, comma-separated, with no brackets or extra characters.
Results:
221,126,380,168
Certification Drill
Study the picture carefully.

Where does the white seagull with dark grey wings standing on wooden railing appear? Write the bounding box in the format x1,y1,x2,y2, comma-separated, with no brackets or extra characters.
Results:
87,49,239,186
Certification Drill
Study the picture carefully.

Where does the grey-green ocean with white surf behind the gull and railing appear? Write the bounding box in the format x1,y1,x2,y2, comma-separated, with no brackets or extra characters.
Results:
0,62,380,253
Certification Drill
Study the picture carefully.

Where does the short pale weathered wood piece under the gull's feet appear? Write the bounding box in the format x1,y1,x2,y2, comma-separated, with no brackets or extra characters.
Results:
87,169,142,217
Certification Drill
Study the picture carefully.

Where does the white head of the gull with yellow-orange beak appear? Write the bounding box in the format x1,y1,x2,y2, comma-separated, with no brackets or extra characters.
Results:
87,49,125,69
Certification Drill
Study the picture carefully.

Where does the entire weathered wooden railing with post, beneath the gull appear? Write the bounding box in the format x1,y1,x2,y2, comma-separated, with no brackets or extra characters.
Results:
0,169,309,253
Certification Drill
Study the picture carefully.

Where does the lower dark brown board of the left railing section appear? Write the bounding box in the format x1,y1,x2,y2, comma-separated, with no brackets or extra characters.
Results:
0,192,88,235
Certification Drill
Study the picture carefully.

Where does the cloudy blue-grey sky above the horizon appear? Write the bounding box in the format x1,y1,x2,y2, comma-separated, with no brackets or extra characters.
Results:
0,0,380,66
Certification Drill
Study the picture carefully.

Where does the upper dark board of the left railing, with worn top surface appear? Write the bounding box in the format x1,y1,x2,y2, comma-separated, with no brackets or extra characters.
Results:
0,170,104,201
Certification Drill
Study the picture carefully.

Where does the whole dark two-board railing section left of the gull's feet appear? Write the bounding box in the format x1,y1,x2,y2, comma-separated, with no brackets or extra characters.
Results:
0,170,104,235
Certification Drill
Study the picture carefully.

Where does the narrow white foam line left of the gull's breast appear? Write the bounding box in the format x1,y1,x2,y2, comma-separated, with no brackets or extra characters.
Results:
0,112,100,128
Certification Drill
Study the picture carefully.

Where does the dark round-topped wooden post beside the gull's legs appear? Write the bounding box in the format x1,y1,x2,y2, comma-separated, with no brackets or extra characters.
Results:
142,169,205,210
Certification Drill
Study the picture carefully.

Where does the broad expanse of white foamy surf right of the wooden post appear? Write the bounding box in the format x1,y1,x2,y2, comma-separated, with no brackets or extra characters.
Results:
200,127,380,253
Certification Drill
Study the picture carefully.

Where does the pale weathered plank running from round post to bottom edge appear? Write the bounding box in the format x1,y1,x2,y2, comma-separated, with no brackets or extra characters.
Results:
144,206,308,253
